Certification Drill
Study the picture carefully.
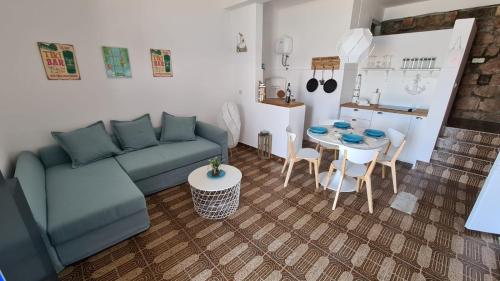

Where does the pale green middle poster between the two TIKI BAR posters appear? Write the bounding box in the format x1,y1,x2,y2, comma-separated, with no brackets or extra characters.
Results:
102,47,132,78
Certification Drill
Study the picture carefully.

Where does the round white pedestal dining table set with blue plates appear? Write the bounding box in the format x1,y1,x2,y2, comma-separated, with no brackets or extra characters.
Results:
307,124,389,192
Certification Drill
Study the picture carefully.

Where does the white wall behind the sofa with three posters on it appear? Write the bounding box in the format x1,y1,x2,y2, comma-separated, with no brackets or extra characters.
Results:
0,0,234,174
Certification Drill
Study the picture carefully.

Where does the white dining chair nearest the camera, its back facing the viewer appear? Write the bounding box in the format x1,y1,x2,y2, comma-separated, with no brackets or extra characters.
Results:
325,145,379,214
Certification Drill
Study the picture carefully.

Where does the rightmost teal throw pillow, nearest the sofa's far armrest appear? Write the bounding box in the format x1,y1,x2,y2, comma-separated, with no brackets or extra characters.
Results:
160,112,196,143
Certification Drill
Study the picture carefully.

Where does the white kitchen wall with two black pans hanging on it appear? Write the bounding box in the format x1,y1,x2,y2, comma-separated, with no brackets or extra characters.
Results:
263,0,353,127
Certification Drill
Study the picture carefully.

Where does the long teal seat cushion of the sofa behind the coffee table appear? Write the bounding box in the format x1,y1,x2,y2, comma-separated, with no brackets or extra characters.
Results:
116,137,221,181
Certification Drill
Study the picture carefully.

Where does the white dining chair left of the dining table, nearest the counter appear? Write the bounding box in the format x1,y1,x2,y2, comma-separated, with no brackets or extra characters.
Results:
281,131,319,188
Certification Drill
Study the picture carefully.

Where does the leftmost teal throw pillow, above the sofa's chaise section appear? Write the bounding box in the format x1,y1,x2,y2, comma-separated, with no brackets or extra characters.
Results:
52,121,121,168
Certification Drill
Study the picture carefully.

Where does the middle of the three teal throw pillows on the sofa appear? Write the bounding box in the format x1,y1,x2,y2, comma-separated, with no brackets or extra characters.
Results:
110,114,159,151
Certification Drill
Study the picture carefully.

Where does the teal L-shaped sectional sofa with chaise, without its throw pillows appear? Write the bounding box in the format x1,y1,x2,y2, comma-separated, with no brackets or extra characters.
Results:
15,121,228,271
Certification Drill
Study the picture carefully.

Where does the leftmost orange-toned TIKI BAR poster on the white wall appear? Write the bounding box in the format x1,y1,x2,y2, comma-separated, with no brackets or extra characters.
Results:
38,42,80,80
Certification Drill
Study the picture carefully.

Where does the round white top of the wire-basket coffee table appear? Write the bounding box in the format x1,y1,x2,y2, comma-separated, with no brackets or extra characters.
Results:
188,165,241,191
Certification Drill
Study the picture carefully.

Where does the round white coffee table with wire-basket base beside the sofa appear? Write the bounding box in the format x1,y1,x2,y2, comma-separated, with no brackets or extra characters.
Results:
188,165,241,219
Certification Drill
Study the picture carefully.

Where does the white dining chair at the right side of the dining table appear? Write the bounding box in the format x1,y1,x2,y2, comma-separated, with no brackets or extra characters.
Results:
377,128,406,193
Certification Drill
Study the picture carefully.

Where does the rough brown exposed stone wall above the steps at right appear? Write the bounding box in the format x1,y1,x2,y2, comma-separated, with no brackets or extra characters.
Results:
382,5,500,123
